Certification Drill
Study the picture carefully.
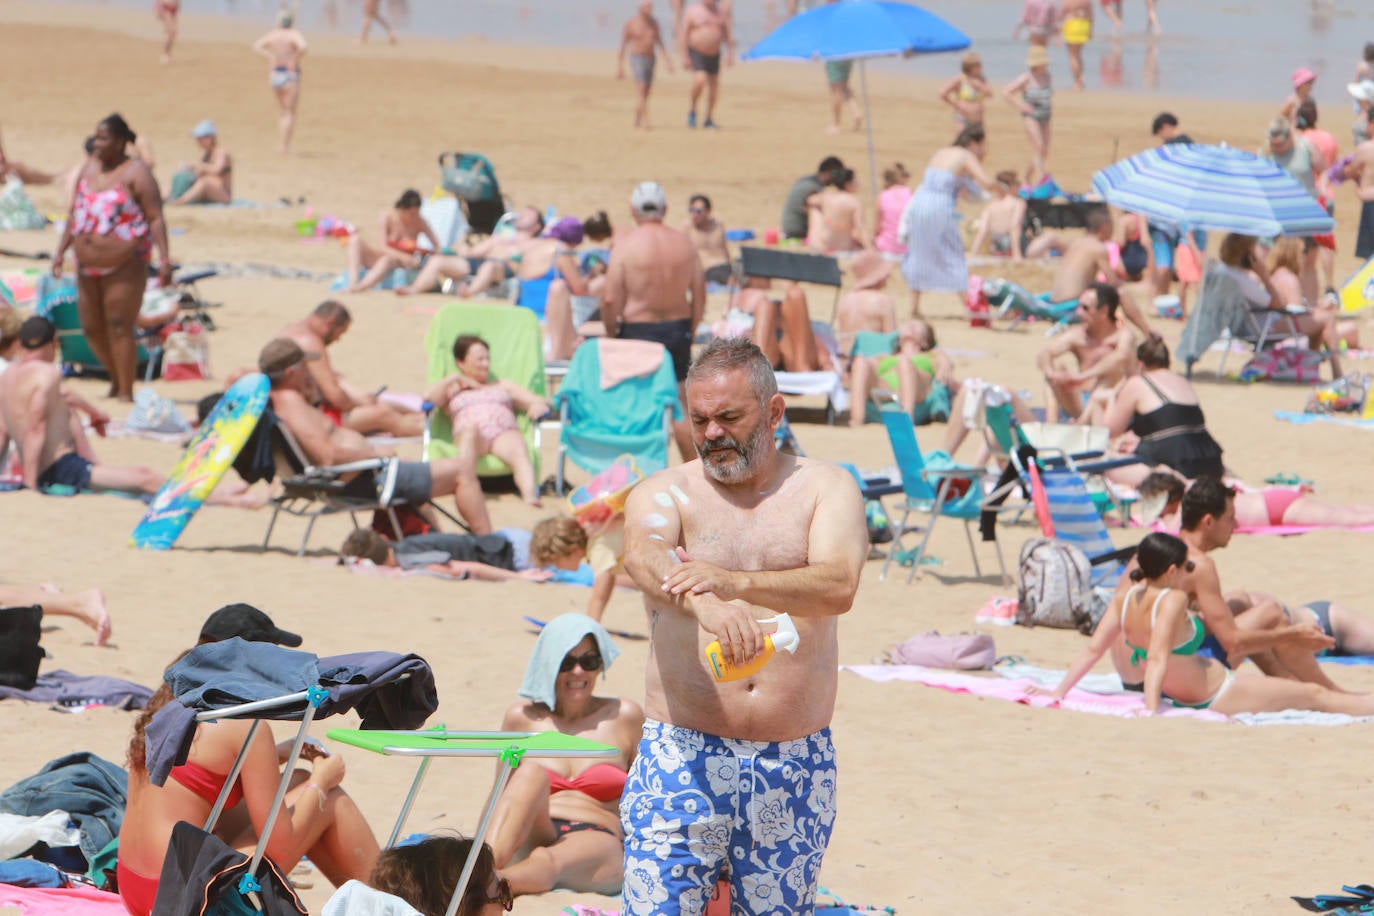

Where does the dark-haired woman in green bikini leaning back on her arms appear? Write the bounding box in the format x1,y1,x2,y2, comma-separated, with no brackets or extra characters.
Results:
1051,533,1374,715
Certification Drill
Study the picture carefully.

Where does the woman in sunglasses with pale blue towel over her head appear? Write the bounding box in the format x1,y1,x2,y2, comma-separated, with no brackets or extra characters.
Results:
491,614,644,897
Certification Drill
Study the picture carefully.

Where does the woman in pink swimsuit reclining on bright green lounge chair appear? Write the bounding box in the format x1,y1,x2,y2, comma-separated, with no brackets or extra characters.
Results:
425,334,550,505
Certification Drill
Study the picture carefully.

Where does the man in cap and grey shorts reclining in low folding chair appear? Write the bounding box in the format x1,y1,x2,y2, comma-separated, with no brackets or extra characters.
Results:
258,338,492,534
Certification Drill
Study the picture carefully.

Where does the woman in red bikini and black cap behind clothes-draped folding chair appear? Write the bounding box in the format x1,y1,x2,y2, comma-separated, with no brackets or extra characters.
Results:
115,604,379,916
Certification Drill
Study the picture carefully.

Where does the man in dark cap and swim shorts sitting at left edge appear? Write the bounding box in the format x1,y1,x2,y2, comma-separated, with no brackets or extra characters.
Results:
0,316,162,493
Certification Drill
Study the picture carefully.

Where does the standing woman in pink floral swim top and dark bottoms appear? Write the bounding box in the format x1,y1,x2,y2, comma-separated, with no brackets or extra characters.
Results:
52,114,172,401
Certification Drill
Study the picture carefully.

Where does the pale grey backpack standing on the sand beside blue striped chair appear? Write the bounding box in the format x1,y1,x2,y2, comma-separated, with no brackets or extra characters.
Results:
1017,537,1101,633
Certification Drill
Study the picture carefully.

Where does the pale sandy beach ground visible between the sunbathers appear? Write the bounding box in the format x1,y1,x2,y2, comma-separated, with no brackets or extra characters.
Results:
0,0,1374,916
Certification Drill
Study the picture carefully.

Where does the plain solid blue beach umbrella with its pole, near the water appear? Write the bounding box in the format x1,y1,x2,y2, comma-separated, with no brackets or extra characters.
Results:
742,0,970,194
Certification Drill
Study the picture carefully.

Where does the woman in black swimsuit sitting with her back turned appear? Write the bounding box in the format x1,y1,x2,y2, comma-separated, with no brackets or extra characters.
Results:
1105,334,1226,486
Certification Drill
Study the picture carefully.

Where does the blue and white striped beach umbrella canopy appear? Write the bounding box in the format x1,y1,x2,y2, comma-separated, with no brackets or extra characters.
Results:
1092,143,1336,238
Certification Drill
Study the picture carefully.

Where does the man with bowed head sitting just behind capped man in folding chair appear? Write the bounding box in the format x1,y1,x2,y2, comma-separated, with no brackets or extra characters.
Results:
282,299,425,438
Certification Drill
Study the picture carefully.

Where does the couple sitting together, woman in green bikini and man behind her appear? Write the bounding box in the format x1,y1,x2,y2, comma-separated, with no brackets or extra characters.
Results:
1051,478,1374,715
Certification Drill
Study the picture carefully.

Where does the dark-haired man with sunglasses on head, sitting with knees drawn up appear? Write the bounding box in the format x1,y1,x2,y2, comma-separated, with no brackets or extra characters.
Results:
1036,283,1135,419
